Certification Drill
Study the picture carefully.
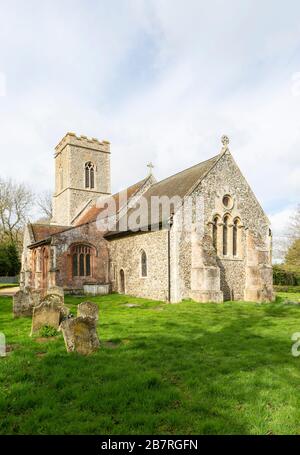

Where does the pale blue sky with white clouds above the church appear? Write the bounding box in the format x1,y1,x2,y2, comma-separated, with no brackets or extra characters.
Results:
0,0,300,235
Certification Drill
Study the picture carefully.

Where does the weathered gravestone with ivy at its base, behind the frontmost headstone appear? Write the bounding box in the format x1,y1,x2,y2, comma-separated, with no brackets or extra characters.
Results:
31,294,69,335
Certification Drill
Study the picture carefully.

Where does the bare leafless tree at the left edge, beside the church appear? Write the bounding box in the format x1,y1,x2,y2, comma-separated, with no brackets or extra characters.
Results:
0,178,33,246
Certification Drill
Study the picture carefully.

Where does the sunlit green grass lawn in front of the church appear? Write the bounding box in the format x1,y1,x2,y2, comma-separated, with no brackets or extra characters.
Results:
0,293,300,434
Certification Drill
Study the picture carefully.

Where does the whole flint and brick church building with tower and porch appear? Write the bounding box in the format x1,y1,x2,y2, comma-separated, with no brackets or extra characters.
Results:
21,133,273,302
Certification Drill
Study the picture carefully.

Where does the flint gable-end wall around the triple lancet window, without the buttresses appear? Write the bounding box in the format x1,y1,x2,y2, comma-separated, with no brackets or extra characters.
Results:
177,153,272,300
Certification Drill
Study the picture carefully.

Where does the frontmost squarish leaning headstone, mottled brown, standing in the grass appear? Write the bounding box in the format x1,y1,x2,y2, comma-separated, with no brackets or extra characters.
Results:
60,317,100,355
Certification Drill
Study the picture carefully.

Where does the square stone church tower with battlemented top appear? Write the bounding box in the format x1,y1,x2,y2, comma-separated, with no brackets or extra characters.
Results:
51,133,111,226
